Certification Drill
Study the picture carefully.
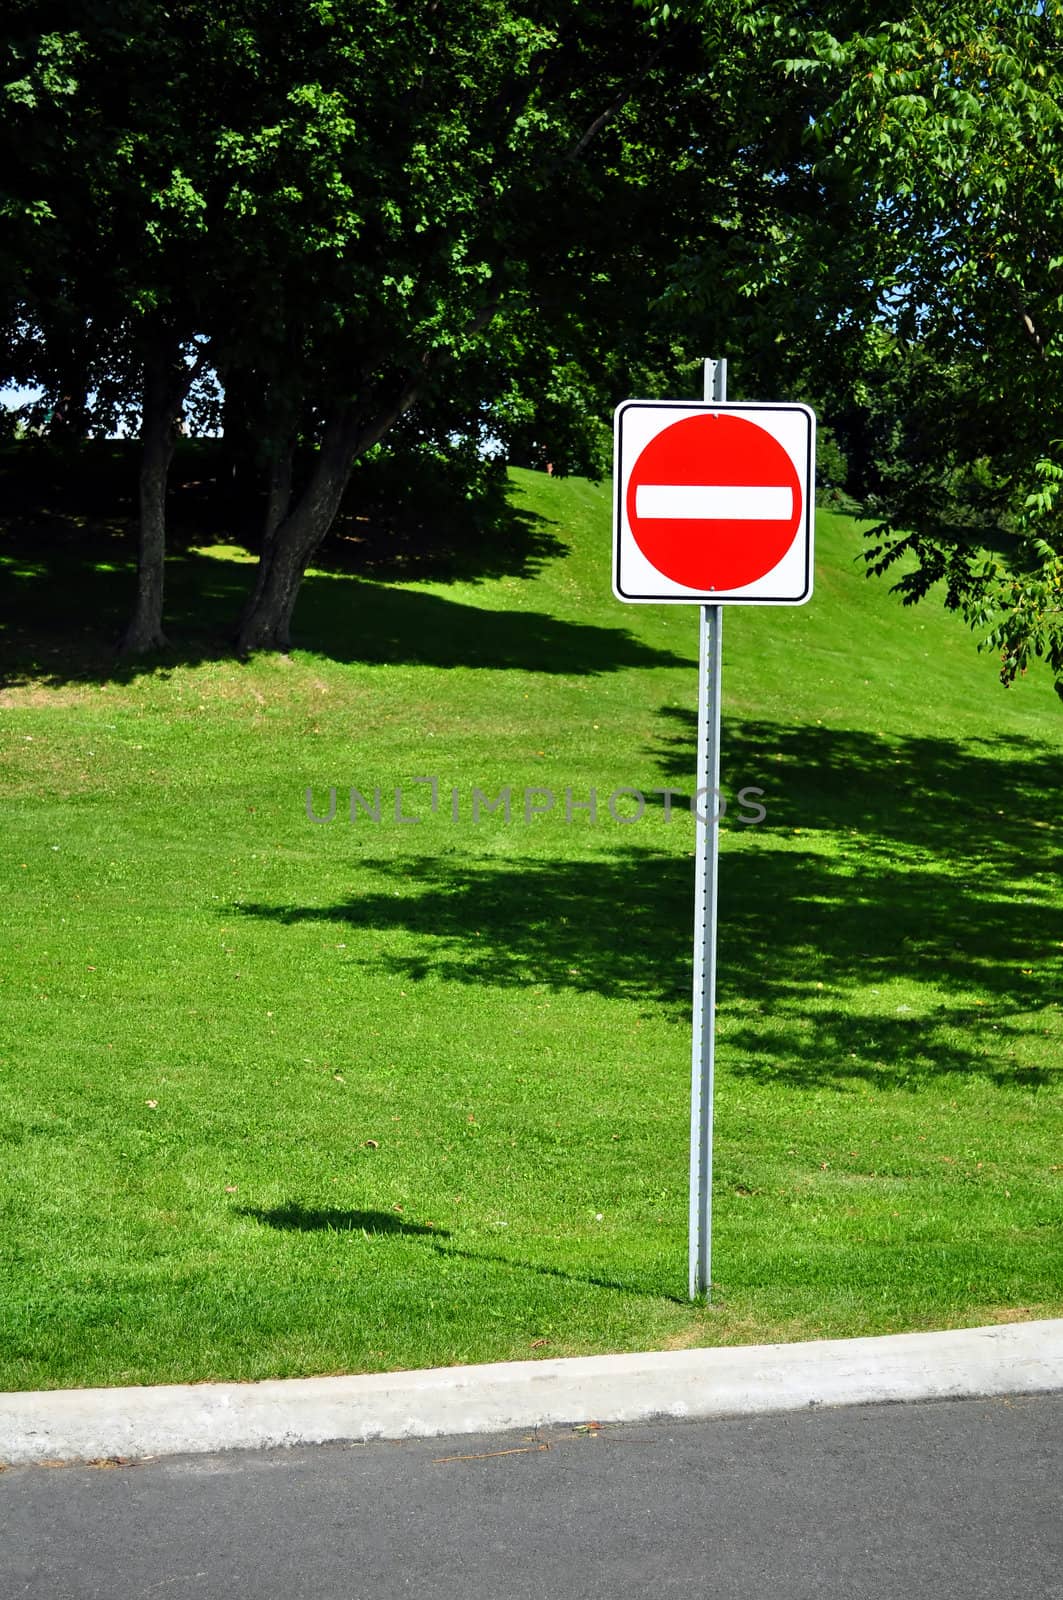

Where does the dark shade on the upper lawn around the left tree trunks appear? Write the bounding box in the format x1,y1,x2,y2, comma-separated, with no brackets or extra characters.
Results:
0,442,690,686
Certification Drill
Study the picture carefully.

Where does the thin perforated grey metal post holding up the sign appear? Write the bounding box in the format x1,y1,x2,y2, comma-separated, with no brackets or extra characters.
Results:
690,360,727,1299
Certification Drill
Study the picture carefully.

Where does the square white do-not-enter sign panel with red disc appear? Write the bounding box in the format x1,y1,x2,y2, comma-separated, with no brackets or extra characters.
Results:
613,400,815,605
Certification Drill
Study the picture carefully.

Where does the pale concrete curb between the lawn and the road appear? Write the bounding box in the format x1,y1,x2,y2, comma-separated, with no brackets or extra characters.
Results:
0,1318,1063,1466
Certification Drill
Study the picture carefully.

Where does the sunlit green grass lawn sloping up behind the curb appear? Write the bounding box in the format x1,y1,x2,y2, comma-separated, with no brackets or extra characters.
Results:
0,472,1063,1389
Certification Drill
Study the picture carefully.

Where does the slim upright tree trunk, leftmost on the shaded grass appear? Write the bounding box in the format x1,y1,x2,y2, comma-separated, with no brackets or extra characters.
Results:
122,344,183,656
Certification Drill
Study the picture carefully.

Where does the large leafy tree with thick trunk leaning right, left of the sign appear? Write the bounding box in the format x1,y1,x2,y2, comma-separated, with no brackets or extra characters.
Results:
209,0,797,650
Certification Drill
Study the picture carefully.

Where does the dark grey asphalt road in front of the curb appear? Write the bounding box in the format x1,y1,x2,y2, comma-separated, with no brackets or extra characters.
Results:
8,1395,1063,1600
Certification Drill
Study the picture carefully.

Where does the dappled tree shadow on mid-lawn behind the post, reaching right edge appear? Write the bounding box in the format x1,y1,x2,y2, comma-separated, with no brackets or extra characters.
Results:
235,723,1063,1088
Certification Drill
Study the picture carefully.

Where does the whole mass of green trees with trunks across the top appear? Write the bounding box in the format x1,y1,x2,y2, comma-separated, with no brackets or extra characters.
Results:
0,0,1063,694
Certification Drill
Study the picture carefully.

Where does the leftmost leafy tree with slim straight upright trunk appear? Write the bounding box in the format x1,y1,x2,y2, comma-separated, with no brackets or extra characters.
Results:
0,0,213,653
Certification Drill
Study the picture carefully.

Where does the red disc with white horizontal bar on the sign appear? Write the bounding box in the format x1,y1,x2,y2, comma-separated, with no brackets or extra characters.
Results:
626,411,804,594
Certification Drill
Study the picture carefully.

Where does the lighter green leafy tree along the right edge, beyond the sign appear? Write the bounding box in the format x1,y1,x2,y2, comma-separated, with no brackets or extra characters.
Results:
746,0,1063,694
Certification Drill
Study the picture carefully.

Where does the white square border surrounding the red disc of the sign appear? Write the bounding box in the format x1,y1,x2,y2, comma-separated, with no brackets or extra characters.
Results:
613,400,816,605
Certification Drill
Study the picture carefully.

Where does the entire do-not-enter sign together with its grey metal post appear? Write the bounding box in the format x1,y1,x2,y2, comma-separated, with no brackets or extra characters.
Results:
613,360,816,1299
